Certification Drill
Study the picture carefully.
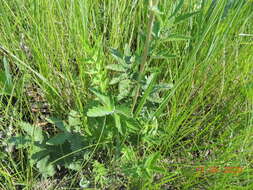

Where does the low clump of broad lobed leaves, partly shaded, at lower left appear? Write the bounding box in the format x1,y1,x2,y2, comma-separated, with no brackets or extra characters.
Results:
8,111,85,177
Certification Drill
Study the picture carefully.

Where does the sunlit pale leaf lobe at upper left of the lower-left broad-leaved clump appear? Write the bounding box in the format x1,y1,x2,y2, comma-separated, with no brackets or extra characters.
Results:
19,122,44,142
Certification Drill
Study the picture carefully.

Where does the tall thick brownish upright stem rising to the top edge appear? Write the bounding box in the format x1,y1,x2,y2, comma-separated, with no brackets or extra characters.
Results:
132,0,159,113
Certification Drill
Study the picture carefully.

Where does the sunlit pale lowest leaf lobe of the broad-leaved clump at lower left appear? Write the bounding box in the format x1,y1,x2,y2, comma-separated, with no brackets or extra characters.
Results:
37,156,55,177
